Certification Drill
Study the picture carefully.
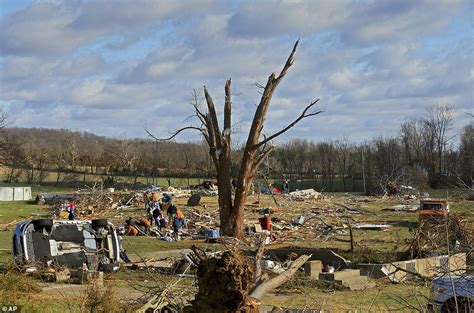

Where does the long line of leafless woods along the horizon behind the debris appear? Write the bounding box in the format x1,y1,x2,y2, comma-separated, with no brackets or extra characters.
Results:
0,105,474,192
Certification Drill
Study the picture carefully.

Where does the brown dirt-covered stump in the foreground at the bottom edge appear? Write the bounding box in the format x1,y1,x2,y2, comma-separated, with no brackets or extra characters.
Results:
184,250,259,313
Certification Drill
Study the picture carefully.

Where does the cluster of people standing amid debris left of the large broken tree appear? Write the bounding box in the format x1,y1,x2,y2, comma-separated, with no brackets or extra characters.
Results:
145,191,187,235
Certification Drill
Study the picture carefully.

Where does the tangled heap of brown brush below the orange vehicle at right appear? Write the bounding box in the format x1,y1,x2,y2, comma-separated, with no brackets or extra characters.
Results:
407,214,474,258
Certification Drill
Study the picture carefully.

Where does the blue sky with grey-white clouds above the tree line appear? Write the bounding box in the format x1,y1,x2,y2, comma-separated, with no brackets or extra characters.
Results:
0,0,474,142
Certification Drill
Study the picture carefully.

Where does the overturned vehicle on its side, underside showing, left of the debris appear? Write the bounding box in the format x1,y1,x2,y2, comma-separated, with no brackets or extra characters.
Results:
13,219,121,271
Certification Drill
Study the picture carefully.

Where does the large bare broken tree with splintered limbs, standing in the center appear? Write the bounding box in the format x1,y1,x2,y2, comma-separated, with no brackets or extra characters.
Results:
147,41,322,237
